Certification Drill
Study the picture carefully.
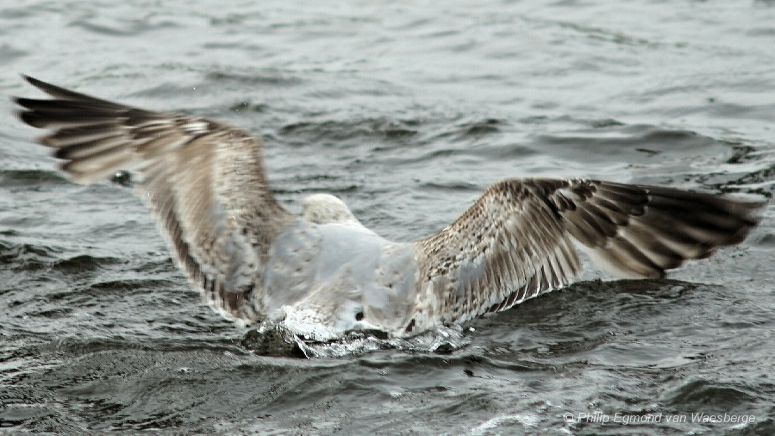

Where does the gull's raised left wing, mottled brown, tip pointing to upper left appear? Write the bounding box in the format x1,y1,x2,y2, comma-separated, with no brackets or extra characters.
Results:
15,77,290,322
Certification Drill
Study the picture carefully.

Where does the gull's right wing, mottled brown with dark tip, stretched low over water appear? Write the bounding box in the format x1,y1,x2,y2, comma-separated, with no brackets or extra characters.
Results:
415,179,766,323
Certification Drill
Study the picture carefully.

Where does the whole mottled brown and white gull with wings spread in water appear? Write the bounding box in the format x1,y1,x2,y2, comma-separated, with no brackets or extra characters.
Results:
15,77,766,341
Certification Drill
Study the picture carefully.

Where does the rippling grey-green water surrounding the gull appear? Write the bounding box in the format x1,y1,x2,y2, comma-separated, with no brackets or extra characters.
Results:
0,0,775,435
